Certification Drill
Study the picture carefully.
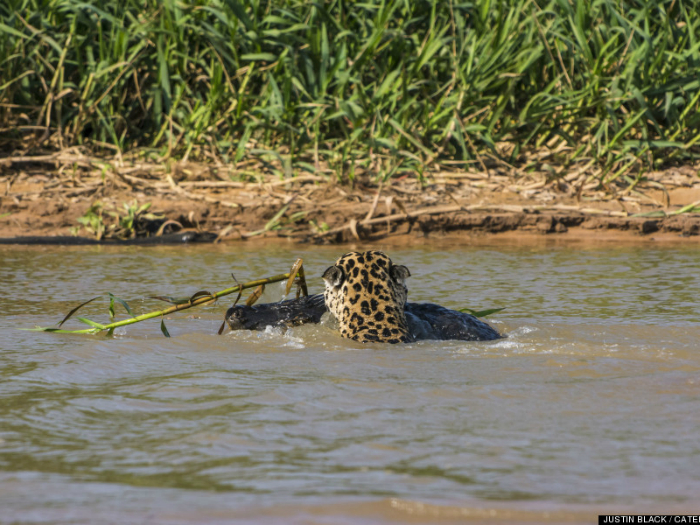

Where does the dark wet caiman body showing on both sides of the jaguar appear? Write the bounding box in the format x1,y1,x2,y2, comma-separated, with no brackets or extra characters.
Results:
226,294,501,341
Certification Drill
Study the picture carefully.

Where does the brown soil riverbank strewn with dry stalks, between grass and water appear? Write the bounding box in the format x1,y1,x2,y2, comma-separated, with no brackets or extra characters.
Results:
0,148,700,243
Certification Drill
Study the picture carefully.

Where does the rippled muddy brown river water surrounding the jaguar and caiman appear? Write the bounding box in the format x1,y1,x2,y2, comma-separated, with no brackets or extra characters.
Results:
0,244,700,525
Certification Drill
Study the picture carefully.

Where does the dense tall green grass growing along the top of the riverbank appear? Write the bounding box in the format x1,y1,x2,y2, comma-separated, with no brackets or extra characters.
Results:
0,0,700,180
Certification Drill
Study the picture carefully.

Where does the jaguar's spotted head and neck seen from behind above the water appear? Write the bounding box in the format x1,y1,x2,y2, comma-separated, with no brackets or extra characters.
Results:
323,251,413,343
